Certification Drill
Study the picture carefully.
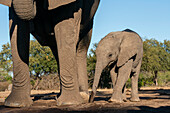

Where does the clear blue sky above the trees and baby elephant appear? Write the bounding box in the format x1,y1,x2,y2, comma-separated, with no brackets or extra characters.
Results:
0,0,170,50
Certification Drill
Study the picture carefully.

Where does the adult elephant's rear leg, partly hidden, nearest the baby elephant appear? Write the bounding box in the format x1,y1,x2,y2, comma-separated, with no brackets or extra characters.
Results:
77,28,92,102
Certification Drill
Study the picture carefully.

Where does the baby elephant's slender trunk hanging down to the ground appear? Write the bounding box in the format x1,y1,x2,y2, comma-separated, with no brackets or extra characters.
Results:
89,62,103,102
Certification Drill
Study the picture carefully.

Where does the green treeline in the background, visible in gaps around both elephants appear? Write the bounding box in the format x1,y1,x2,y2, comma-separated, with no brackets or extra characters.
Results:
0,39,170,88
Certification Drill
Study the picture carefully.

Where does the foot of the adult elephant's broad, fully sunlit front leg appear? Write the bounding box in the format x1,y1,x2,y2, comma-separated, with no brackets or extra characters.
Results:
57,91,84,106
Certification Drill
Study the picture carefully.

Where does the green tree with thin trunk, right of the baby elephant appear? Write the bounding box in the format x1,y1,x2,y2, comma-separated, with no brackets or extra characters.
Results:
141,39,170,85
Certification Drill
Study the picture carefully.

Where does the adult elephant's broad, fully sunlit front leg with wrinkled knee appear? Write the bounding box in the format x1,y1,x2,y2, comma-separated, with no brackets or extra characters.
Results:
55,11,83,105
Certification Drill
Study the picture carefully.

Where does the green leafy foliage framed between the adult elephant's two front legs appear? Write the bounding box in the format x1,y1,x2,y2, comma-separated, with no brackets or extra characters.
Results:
29,40,57,76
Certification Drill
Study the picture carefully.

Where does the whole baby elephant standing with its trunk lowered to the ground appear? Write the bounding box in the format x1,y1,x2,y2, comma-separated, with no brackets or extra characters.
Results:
90,29,143,102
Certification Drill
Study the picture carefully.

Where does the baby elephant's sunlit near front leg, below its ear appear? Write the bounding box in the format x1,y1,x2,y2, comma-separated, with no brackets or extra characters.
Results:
109,59,133,102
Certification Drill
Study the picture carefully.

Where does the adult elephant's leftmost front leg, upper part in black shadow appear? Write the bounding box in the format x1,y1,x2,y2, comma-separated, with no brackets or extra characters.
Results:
5,8,32,107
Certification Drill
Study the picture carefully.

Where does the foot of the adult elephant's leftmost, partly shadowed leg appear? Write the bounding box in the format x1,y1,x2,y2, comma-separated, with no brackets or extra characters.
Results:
4,91,33,107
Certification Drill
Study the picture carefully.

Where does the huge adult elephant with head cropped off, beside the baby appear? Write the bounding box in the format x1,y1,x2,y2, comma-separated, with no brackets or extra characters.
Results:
0,0,100,107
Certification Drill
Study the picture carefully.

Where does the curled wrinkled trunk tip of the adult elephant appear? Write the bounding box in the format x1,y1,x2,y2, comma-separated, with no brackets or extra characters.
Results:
12,0,36,20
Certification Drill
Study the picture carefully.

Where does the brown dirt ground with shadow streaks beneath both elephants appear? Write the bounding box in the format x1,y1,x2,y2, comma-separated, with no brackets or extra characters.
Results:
0,87,170,113
